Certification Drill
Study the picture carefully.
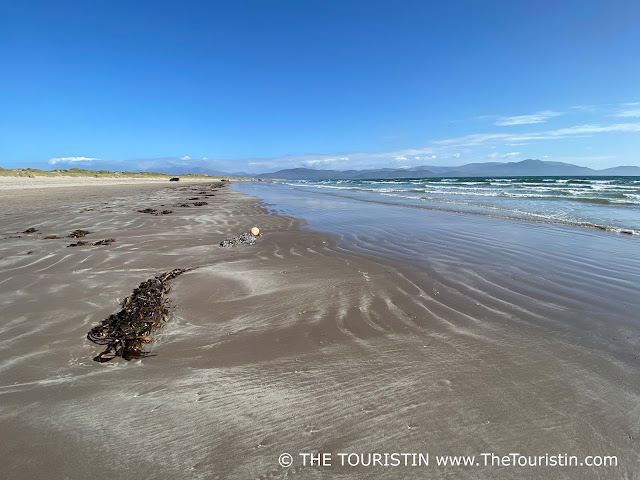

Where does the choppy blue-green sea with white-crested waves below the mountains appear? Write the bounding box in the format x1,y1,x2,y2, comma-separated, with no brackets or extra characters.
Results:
272,177,640,235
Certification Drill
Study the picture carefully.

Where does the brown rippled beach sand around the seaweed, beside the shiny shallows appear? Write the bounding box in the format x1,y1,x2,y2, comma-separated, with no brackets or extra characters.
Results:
0,183,640,479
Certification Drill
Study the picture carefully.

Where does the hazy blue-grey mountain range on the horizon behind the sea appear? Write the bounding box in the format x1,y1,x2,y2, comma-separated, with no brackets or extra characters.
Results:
251,159,640,180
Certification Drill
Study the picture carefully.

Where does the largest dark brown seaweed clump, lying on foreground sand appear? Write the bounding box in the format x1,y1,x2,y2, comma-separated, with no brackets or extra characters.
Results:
87,268,193,362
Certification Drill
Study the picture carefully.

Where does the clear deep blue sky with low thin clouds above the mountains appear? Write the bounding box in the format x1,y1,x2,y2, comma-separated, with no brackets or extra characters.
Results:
0,0,640,172
